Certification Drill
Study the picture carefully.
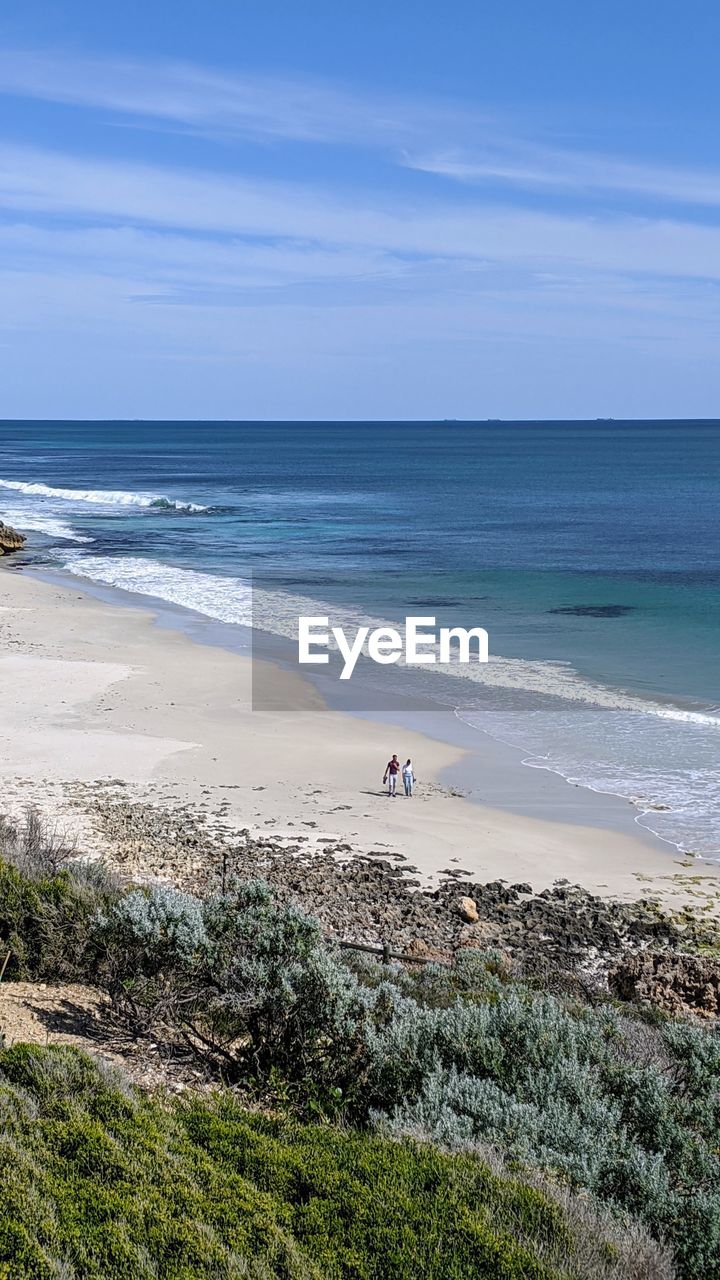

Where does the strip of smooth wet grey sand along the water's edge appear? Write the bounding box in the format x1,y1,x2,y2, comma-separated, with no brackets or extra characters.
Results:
23,558,720,864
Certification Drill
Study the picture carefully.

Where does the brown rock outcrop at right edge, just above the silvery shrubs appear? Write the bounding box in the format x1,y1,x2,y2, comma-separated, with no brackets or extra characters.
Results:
609,951,720,1018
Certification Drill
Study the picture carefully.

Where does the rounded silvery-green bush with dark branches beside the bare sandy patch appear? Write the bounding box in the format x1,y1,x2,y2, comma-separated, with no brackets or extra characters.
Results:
96,881,370,1105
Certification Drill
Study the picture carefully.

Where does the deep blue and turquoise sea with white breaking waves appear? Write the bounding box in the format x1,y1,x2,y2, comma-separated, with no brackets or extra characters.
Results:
0,421,720,856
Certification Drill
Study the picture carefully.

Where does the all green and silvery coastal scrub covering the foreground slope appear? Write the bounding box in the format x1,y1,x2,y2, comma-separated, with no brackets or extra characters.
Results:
0,832,720,1280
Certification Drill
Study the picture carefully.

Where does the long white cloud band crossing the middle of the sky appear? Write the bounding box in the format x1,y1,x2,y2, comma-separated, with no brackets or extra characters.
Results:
0,147,720,280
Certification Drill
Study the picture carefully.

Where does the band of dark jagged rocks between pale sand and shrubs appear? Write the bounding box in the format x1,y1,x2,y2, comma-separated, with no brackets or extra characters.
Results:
61,780,720,1011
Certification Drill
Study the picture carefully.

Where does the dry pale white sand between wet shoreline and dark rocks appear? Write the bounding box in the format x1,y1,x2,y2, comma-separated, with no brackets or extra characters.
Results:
0,567,720,905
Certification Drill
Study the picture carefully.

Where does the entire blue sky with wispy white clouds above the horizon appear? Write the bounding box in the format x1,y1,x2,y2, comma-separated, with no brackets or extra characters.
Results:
0,0,720,419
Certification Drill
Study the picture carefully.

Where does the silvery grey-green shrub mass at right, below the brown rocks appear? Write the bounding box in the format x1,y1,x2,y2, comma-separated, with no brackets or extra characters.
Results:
368,988,720,1280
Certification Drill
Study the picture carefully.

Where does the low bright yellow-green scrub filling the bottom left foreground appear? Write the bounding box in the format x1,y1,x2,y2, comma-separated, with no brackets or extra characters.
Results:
0,1046,673,1280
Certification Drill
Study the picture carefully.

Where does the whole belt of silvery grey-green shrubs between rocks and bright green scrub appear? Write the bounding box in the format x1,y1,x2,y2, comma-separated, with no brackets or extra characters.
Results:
8,868,720,1280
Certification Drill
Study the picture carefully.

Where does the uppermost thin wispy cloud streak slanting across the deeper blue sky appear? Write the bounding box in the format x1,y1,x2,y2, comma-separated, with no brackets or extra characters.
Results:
0,50,720,215
